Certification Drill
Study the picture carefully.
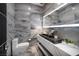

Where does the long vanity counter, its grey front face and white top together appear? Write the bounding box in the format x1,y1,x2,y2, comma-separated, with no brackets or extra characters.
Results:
38,35,79,56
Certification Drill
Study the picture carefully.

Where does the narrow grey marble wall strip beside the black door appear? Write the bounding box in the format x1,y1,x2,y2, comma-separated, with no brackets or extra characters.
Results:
7,3,15,55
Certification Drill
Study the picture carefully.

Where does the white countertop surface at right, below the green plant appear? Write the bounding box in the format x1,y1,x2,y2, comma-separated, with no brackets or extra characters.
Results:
54,42,79,56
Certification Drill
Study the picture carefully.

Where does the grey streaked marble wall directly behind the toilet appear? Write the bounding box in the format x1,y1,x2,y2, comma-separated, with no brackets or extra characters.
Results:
15,3,31,43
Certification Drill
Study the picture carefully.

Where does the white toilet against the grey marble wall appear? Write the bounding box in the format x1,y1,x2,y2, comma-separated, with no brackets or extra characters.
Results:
12,38,29,56
